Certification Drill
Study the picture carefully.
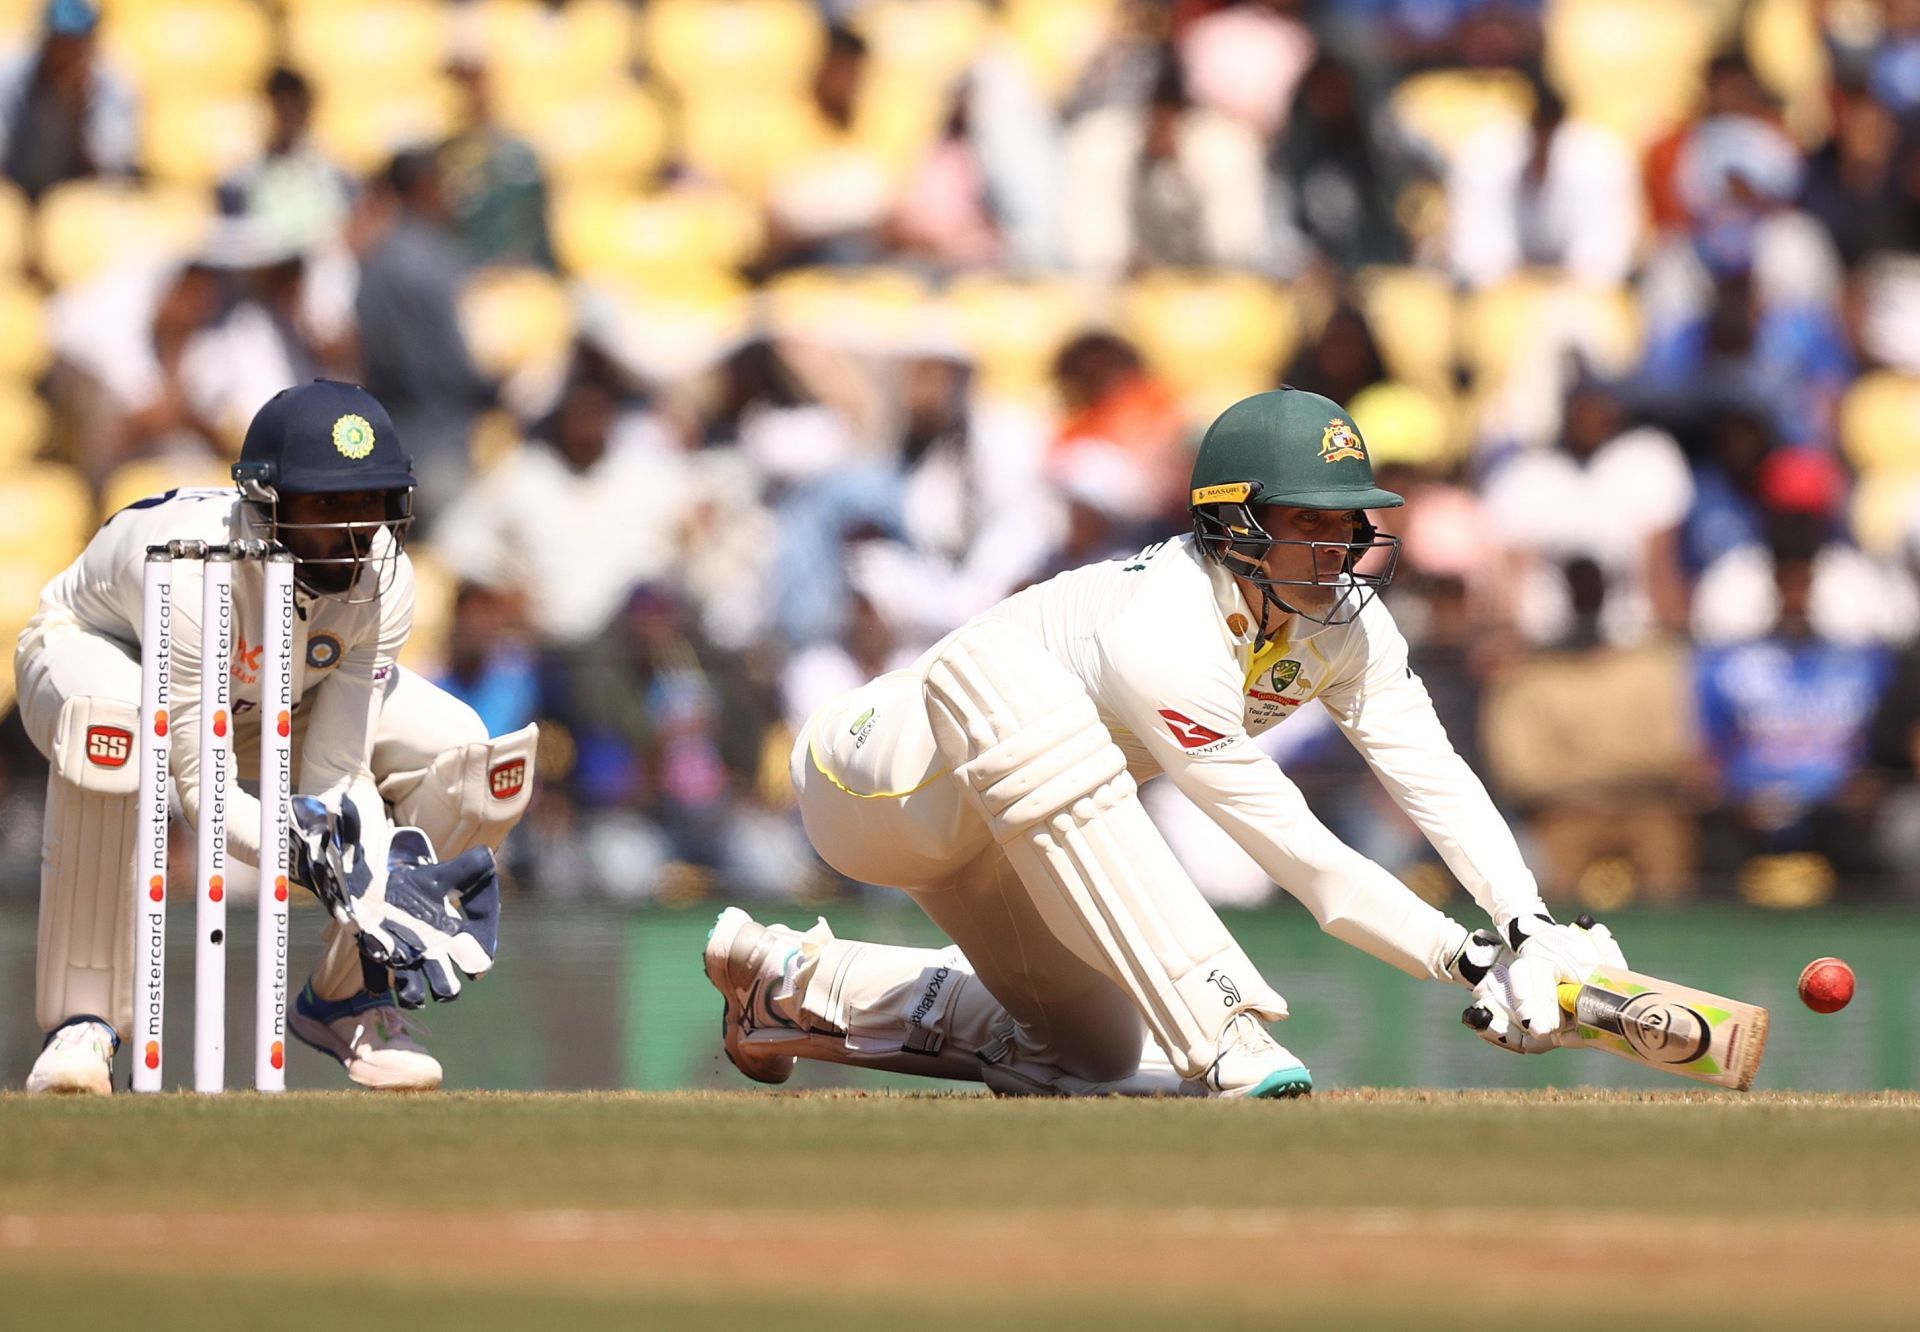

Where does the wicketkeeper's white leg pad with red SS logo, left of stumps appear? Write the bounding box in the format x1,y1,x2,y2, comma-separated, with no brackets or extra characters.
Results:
35,697,141,1035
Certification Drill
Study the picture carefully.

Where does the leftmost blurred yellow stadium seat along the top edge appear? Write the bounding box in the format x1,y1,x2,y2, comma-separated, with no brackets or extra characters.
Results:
100,0,273,96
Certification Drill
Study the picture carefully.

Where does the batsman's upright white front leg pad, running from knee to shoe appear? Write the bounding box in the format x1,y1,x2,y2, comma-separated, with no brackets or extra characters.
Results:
925,620,1286,1079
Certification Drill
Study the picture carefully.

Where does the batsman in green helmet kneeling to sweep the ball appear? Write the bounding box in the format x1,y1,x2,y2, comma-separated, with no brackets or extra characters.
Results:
705,390,1624,1098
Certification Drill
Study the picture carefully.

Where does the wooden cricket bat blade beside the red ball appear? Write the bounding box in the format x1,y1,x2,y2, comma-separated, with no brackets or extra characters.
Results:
1559,967,1766,1092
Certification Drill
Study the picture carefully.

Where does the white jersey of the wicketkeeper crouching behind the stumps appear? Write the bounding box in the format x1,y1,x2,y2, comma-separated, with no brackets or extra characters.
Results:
21,488,413,864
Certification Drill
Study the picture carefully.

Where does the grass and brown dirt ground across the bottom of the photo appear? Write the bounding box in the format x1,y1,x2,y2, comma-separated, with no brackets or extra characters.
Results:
0,1090,1920,1332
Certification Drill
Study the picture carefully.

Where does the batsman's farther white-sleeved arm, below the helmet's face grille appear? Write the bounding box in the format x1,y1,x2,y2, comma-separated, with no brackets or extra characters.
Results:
1319,603,1546,933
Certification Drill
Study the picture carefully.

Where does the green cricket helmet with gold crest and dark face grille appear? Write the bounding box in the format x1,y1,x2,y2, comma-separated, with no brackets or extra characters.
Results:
1187,388,1407,624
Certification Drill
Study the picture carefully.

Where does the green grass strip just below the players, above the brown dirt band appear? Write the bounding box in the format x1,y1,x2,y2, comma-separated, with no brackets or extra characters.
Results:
0,1092,1920,1215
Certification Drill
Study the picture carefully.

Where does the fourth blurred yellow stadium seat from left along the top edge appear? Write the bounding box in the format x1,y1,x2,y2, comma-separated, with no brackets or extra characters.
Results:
636,0,826,98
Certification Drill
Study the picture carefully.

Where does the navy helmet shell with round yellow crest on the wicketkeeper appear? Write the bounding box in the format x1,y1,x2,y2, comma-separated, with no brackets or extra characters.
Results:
234,380,413,495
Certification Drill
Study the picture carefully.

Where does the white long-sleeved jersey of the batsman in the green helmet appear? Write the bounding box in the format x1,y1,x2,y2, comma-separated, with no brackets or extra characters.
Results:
989,535,1540,977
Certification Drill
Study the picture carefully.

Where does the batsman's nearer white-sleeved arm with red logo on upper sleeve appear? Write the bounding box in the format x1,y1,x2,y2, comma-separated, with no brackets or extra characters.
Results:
1106,625,1467,981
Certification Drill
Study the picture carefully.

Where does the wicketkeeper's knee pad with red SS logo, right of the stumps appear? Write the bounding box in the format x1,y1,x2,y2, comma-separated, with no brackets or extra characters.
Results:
380,725,540,860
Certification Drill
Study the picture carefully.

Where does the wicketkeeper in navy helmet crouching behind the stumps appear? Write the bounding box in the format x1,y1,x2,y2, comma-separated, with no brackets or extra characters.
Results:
15,380,536,1092
